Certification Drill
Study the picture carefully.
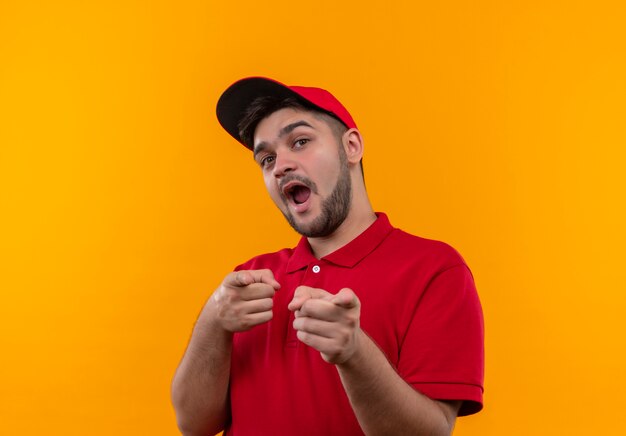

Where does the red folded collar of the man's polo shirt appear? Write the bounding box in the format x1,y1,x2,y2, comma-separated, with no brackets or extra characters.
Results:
287,212,393,273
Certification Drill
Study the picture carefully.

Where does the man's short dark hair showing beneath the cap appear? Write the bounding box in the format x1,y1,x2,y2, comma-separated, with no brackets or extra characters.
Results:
237,96,363,177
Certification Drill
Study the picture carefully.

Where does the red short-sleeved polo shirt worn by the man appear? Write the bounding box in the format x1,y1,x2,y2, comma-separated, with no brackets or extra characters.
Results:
225,213,484,436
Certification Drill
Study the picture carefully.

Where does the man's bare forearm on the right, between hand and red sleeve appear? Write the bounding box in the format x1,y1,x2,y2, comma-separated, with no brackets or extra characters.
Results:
337,331,459,436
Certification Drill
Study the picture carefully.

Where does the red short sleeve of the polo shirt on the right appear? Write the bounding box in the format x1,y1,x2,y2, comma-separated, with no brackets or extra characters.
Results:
398,264,484,416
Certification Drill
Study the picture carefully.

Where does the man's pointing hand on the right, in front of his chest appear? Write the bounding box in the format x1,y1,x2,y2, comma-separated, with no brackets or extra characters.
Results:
288,286,361,364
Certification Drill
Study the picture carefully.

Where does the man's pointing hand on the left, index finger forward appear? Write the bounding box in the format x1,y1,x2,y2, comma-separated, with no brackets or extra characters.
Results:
209,269,280,332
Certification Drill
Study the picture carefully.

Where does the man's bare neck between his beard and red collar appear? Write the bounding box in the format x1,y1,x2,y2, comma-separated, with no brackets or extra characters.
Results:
308,207,376,259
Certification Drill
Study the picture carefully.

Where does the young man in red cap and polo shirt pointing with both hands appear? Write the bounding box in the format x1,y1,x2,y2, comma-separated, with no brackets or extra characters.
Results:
172,77,483,435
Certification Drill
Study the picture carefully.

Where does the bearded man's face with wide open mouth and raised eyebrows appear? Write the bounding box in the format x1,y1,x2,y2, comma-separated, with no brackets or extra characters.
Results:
254,108,352,237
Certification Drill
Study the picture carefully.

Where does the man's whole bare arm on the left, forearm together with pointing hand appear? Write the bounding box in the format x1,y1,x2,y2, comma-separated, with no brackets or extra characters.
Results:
172,269,280,436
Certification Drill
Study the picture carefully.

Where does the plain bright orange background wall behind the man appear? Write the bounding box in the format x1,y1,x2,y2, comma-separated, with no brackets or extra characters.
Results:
0,0,626,436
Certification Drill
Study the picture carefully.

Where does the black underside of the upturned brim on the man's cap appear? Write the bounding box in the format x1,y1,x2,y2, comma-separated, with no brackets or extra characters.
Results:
217,77,300,145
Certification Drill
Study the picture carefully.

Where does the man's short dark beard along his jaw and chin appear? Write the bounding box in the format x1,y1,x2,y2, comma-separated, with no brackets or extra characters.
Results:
283,147,352,238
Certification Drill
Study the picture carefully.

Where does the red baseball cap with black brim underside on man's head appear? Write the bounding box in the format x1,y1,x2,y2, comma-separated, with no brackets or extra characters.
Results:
217,77,356,149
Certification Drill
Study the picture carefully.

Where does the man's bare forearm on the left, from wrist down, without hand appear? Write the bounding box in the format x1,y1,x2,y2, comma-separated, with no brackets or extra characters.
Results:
172,304,232,436
